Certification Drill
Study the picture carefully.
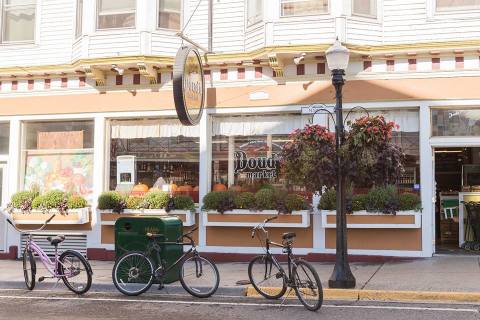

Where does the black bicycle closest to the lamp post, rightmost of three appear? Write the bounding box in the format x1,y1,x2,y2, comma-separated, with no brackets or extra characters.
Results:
248,217,323,311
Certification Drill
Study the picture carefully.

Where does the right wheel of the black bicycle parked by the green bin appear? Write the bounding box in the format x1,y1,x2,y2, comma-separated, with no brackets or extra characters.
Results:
180,255,220,298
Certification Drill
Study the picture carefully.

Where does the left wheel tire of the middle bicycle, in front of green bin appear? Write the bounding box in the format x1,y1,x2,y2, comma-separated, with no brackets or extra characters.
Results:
112,251,154,296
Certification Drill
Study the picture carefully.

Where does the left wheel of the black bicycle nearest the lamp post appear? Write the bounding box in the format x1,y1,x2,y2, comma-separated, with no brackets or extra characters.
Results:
248,255,287,300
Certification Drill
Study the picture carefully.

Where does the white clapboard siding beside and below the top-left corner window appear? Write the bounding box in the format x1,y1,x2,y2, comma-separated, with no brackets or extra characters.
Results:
0,0,76,67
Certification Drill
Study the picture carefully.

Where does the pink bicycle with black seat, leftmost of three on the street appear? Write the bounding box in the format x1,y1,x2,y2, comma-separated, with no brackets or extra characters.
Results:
7,215,93,294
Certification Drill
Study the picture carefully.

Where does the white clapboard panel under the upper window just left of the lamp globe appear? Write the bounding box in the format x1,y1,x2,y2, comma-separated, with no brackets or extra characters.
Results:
273,15,335,45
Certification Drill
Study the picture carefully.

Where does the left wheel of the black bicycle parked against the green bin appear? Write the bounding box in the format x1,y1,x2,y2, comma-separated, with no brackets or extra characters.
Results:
112,251,154,296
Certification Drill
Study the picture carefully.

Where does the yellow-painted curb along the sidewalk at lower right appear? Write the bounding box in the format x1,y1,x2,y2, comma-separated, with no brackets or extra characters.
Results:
246,287,480,304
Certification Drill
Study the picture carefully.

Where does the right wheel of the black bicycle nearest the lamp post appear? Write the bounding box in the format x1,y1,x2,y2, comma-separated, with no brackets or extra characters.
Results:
292,260,323,311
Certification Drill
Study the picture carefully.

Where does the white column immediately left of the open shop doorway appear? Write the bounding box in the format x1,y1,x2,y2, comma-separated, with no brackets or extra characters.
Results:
419,104,435,257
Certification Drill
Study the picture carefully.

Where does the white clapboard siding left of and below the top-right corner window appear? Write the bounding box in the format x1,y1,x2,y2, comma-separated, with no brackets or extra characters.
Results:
383,0,480,43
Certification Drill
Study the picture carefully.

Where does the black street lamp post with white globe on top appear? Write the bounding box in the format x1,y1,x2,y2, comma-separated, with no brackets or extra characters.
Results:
326,39,356,289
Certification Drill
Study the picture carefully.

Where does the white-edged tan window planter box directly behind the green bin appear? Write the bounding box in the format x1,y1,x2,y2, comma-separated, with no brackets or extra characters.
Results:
100,209,195,227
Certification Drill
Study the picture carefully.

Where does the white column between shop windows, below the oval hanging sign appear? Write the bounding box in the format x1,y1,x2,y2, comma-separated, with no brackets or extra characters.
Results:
198,114,212,247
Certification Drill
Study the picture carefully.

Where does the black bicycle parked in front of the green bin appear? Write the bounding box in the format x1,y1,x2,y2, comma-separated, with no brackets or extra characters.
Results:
112,228,220,298
